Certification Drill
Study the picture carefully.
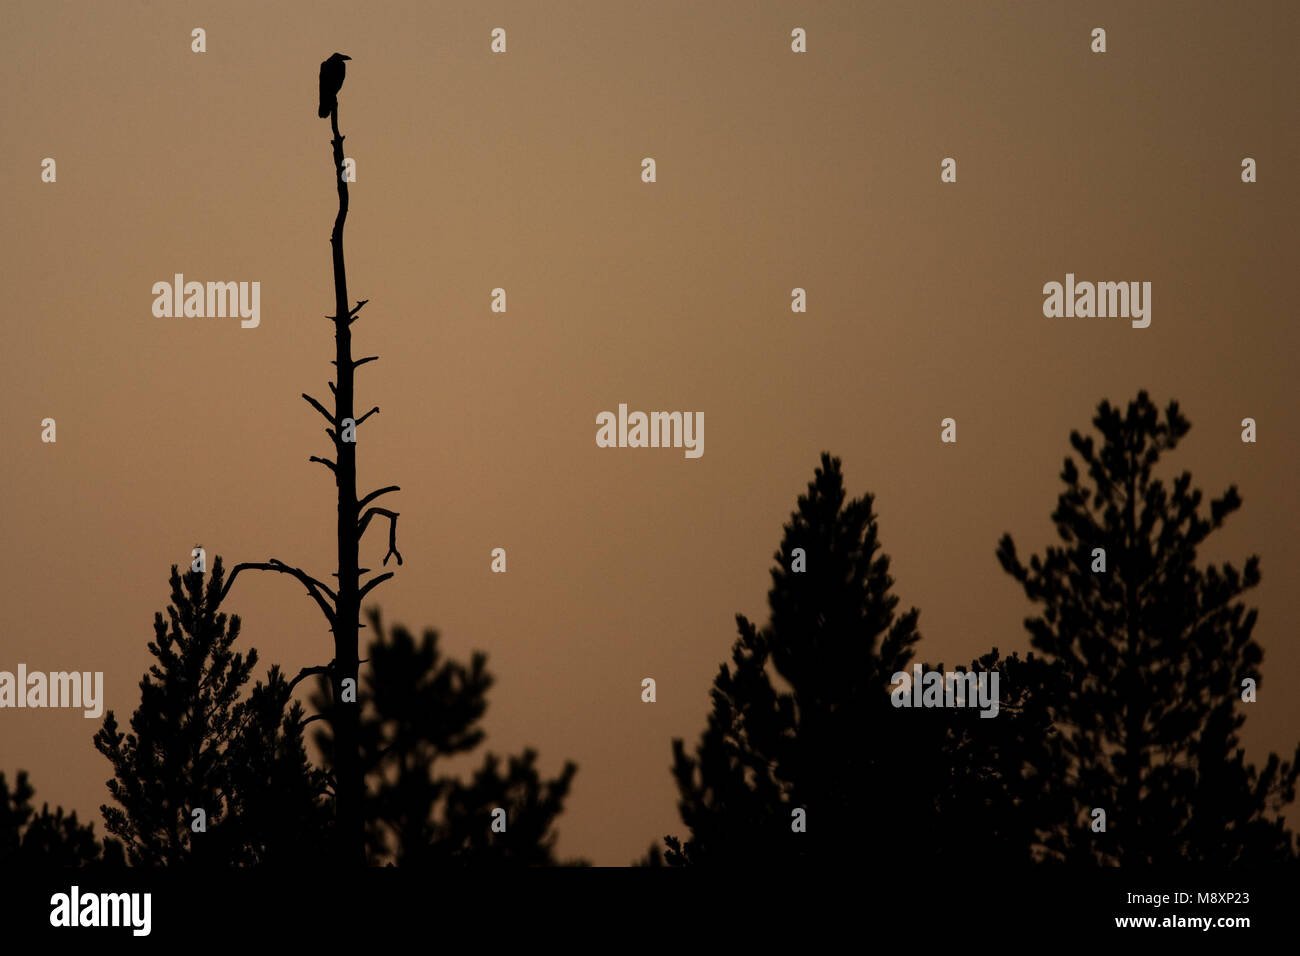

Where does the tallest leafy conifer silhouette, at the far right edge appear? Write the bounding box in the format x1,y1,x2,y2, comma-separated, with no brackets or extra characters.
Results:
997,392,1300,865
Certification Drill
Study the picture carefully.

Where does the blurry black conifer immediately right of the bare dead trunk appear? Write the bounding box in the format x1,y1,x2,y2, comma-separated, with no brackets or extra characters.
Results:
313,610,577,866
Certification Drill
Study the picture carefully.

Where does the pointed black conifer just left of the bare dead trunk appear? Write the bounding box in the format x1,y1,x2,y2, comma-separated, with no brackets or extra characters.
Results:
95,557,328,866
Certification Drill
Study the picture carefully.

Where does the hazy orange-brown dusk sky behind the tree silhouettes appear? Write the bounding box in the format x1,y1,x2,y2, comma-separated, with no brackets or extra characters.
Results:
0,0,1300,864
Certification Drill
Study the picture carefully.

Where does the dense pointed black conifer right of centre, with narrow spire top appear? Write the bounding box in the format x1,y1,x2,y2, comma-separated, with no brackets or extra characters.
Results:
651,453,939,865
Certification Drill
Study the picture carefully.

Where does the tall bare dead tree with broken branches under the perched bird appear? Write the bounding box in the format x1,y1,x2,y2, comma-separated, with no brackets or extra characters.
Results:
221,80,402,865
